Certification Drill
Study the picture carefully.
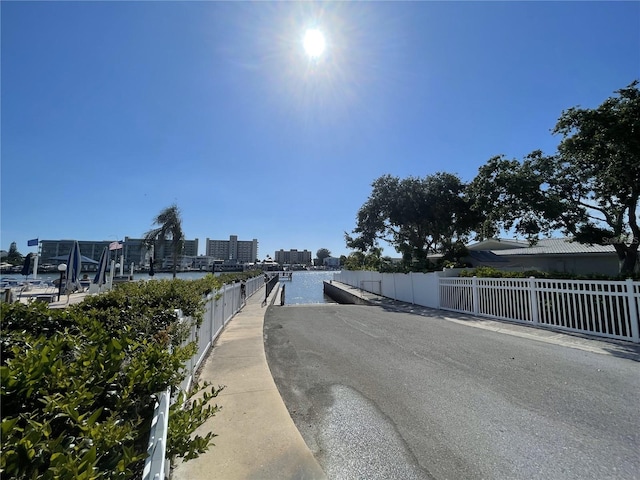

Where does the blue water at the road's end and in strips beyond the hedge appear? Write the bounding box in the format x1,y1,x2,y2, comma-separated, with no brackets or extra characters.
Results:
10,271,337,305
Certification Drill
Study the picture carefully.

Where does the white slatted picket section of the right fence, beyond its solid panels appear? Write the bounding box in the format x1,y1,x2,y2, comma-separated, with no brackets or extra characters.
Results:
439,277,640,343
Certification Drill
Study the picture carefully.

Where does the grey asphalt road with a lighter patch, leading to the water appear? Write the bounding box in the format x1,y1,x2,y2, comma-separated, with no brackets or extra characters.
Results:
264,305,640,480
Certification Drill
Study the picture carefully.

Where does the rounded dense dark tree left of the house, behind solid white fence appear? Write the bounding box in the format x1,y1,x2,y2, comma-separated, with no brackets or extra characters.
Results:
345,172,474,269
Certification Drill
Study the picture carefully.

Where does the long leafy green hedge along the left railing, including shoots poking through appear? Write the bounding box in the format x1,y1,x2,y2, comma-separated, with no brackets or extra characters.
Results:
0,273,259,480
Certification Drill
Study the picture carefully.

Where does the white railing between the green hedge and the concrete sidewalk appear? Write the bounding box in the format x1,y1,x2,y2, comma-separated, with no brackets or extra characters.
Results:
142,277,264,480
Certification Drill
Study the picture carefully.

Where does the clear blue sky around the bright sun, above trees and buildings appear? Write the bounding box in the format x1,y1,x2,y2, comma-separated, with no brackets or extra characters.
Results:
0,1,640,258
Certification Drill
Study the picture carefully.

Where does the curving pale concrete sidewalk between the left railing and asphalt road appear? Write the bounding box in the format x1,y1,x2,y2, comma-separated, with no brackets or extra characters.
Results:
171,288,326,480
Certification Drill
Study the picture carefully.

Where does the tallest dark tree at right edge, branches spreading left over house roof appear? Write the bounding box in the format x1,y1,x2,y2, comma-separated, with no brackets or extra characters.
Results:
470,81,640,273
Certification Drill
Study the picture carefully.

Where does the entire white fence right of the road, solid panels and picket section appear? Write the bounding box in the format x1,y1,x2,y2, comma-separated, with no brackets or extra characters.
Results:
334,271,640,343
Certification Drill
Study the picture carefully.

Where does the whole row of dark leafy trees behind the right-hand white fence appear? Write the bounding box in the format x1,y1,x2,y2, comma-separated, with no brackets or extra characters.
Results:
345,80,640,274
